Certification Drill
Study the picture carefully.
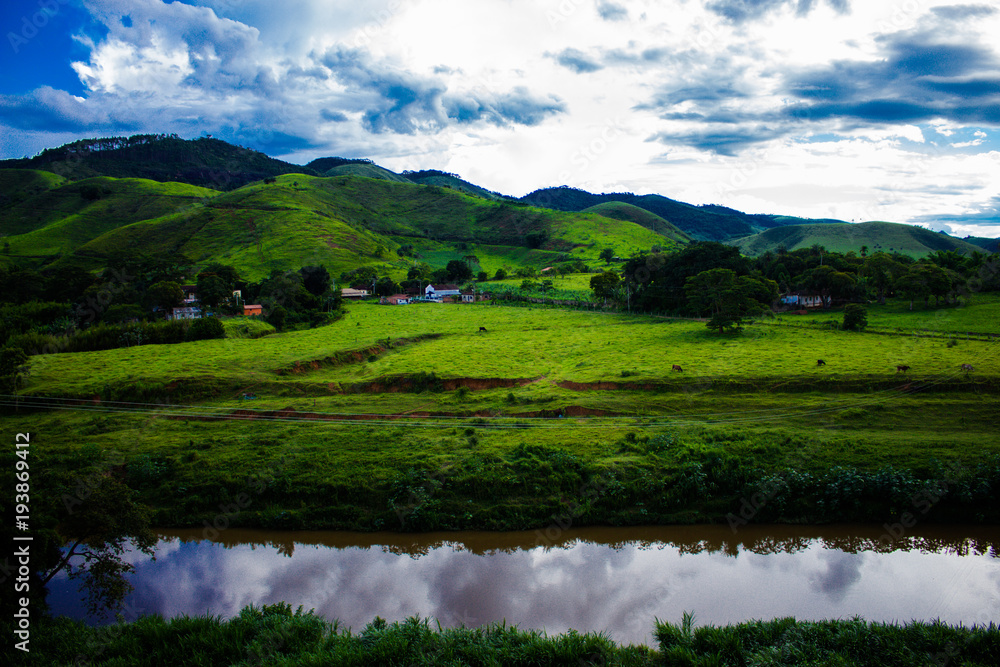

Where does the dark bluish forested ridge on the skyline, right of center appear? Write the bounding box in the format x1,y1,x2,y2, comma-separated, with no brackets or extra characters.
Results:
521,186,844,241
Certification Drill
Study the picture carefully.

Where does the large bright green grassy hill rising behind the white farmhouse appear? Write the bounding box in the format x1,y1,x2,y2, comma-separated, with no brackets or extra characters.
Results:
58,174,674,278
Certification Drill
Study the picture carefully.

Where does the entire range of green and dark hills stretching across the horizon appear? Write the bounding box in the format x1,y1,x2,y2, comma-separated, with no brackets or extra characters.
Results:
0,135,996,275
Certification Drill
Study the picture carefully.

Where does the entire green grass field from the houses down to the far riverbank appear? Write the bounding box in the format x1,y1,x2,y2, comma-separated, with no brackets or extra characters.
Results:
5,299,1000,530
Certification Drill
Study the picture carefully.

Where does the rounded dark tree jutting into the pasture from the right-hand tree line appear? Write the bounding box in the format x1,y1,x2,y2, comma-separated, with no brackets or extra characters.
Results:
684,269,778,334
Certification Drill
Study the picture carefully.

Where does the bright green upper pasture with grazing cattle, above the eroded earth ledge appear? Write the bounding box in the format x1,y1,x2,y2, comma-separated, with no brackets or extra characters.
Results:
25,303,1000,402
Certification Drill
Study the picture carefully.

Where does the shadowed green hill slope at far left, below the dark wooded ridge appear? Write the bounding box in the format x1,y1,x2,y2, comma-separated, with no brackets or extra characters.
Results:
0,171,218,262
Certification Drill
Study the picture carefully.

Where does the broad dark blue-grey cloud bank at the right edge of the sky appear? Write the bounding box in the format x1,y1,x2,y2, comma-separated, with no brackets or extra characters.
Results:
636,23,1000,155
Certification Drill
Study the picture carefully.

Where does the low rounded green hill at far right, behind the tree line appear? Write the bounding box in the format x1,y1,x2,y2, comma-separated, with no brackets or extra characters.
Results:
730,222,982,257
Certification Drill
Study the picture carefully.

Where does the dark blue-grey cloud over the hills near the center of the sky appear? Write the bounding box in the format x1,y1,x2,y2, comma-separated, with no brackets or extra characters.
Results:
320,48,565,134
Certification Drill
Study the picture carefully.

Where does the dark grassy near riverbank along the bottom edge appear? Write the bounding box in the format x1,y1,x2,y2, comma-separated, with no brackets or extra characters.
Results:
21,604,1000,667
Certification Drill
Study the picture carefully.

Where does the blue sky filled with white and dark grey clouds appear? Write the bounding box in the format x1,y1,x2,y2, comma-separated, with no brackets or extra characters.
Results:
0,0,1000,238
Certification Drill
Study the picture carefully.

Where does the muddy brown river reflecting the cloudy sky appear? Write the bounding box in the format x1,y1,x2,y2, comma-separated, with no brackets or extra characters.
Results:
49,525,1000,644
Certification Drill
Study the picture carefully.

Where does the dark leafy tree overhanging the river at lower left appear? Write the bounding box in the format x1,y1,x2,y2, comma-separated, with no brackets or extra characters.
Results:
41,473,157,615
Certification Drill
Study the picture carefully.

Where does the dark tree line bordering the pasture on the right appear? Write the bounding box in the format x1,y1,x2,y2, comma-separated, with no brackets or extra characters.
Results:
591,242,1000,331
